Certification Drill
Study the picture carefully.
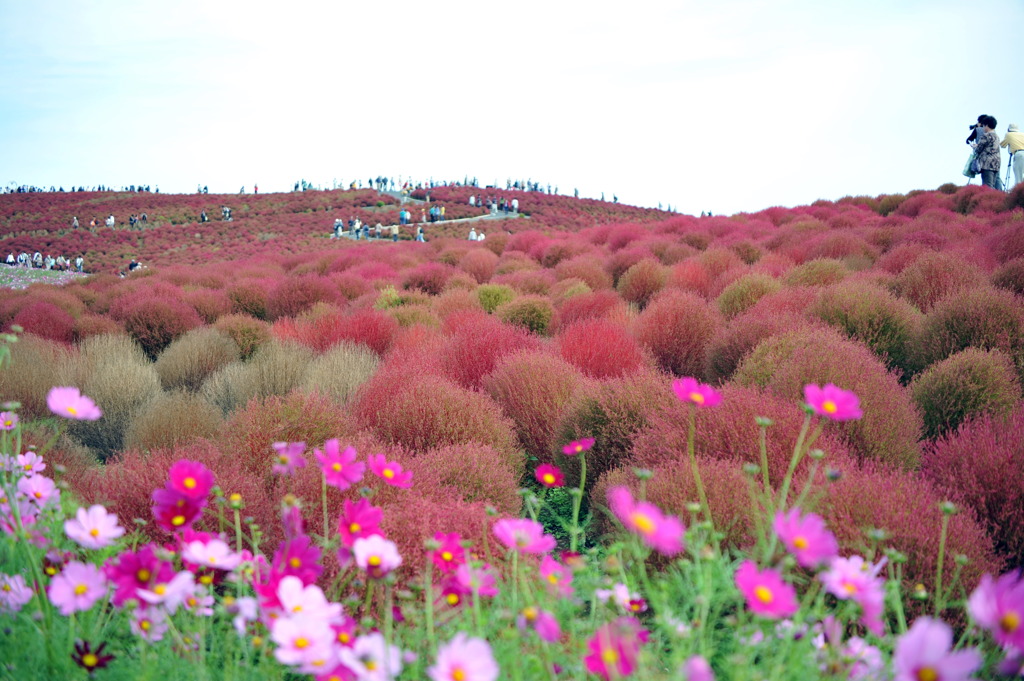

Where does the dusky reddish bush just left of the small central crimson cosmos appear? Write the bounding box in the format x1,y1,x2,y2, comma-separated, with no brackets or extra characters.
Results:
408,442,522,516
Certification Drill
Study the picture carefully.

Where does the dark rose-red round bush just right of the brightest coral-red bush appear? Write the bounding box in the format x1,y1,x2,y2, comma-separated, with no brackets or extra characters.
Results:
633,289,722,376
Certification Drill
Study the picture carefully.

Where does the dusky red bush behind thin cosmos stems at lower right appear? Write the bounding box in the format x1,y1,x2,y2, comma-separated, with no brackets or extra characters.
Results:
819,463,1001,593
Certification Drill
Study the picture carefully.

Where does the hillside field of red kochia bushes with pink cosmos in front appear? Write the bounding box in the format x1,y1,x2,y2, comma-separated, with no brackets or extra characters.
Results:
0,185,1024,681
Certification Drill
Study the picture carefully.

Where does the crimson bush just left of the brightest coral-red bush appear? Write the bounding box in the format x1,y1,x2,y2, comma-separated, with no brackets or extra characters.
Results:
439,315,540,388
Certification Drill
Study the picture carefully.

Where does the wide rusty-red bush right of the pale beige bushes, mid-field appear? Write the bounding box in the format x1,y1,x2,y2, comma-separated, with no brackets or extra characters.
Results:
352,370,524,475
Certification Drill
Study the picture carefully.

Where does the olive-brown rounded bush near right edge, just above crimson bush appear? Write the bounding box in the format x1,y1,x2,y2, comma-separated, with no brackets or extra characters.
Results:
910,347,1021,437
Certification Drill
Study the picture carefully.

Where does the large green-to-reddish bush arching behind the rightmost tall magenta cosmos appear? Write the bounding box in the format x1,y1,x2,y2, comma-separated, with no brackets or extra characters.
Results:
733,328,922,468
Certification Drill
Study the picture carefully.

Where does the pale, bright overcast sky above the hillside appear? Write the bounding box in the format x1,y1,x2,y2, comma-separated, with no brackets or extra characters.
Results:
0,0,1024,214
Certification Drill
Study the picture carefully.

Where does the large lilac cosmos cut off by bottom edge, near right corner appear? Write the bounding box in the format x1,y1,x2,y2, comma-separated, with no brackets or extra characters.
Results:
893,618,982,681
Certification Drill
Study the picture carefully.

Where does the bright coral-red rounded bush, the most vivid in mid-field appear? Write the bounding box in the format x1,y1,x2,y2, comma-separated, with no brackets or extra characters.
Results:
557,320,647,379
